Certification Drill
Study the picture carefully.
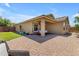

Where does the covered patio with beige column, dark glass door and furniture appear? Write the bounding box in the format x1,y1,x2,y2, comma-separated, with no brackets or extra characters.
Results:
33,19,57,36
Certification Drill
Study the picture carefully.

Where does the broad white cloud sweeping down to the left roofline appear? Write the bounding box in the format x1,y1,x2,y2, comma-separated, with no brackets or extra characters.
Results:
0,8,34,23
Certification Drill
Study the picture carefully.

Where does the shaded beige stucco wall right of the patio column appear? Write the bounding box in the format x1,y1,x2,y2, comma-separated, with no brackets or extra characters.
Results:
46,22,66,34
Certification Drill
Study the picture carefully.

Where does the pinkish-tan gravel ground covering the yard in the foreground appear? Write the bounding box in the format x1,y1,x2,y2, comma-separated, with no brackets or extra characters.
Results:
7,33,79,56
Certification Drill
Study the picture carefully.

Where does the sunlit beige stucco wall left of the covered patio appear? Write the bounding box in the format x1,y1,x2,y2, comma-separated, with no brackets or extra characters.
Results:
15,21,33,34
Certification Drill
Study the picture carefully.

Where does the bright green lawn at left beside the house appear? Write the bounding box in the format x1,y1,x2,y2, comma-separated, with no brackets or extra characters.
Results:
0,32,21,41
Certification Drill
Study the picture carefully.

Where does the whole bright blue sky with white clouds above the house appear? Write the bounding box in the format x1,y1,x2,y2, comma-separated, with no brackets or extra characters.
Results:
0,3,79,26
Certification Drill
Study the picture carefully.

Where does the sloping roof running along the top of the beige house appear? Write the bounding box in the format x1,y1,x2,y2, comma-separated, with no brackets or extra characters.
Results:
15,14,68,24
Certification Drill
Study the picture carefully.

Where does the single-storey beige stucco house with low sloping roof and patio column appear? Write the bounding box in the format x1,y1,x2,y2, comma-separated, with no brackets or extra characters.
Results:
15,14,69,36
